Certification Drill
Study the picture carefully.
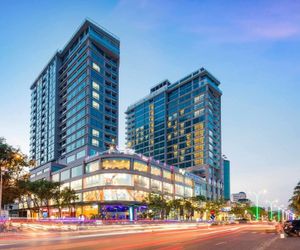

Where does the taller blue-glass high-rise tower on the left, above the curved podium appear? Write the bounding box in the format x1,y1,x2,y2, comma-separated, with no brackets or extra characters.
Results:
30,20,120,172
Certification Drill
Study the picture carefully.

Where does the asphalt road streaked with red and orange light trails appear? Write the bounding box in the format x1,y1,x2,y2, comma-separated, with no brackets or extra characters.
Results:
0,225,300,250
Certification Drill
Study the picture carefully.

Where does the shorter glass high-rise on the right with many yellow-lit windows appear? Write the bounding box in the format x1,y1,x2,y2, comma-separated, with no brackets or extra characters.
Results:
126,68,224,199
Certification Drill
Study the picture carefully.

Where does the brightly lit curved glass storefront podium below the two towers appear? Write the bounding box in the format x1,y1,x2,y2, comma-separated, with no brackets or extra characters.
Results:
24,151,206,219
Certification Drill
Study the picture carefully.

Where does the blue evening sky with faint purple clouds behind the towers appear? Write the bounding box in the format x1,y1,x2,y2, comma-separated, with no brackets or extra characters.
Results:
0,0,300,207
